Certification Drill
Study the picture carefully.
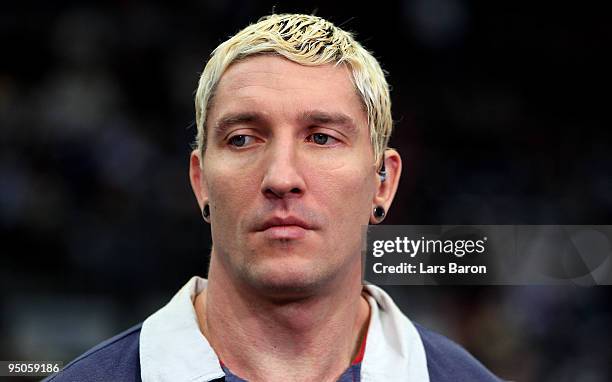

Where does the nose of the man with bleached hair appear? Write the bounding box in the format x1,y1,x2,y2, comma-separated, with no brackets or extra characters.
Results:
261,144,306,199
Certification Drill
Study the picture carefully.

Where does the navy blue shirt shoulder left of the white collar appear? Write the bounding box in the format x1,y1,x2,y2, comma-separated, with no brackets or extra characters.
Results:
43,323,142,382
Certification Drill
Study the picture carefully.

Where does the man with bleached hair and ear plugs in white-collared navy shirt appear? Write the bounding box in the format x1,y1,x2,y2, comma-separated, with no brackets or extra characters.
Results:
46,15,497,381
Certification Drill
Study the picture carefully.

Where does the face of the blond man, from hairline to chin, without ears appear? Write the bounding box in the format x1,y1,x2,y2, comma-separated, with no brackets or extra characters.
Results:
195,55,379,293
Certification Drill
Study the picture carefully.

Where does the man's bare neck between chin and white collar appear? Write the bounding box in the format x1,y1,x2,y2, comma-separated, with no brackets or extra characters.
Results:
194,255,369,381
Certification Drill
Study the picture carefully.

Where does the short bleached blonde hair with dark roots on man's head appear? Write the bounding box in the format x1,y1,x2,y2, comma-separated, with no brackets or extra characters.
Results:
195,14,393,164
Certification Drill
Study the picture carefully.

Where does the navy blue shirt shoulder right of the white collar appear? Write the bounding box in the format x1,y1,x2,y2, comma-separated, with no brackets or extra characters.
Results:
414,323,500,382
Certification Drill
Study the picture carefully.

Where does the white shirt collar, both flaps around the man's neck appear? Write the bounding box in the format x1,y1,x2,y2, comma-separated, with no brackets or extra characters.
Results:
140,276,429,382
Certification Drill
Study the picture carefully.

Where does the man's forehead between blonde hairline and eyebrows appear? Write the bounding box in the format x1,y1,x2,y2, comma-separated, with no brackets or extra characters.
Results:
209,55,367,124
